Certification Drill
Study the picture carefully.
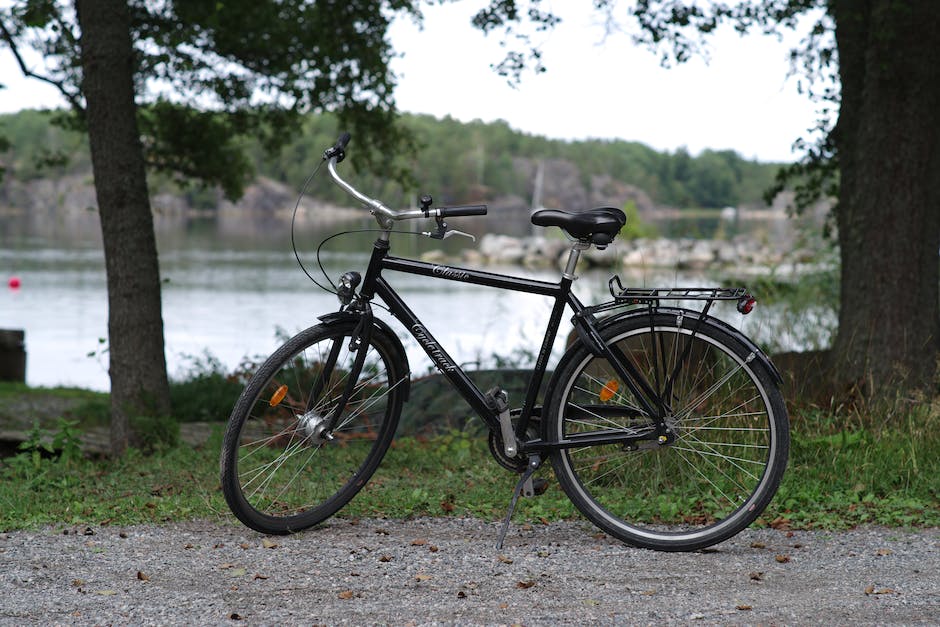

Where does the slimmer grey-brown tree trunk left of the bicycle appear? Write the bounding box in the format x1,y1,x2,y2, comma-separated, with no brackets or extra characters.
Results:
75,0,169,455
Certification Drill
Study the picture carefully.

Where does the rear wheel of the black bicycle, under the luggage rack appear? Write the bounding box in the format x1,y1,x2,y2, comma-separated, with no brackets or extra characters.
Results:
542,310,789,551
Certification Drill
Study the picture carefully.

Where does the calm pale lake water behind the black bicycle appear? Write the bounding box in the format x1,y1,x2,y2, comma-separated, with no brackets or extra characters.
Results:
0,213,831,390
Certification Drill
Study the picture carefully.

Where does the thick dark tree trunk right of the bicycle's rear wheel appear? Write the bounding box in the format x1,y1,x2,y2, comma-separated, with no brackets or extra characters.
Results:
830,0,940,396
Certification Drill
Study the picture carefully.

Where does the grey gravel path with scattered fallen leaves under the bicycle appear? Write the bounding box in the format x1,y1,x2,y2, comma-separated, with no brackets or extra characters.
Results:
0,519,940,625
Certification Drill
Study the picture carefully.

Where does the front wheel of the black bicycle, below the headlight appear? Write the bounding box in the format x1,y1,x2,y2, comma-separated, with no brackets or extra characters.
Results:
220,320,409,534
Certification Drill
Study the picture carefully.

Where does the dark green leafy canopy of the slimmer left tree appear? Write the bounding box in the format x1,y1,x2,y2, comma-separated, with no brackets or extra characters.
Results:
0,0,420,198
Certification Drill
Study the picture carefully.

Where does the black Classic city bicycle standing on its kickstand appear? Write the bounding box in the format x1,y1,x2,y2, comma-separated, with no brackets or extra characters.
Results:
220,133,789,551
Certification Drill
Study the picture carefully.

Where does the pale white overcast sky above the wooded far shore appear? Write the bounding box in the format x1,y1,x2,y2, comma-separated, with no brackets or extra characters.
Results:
0,0,817,161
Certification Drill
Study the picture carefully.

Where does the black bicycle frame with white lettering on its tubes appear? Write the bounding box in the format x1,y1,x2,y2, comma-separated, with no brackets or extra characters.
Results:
360,239,666,452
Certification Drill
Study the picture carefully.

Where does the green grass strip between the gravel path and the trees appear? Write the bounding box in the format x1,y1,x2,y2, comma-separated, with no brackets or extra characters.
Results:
0,394,940,531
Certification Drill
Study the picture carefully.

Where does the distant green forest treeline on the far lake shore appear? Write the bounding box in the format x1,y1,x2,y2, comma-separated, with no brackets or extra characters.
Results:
0,111,779,208
